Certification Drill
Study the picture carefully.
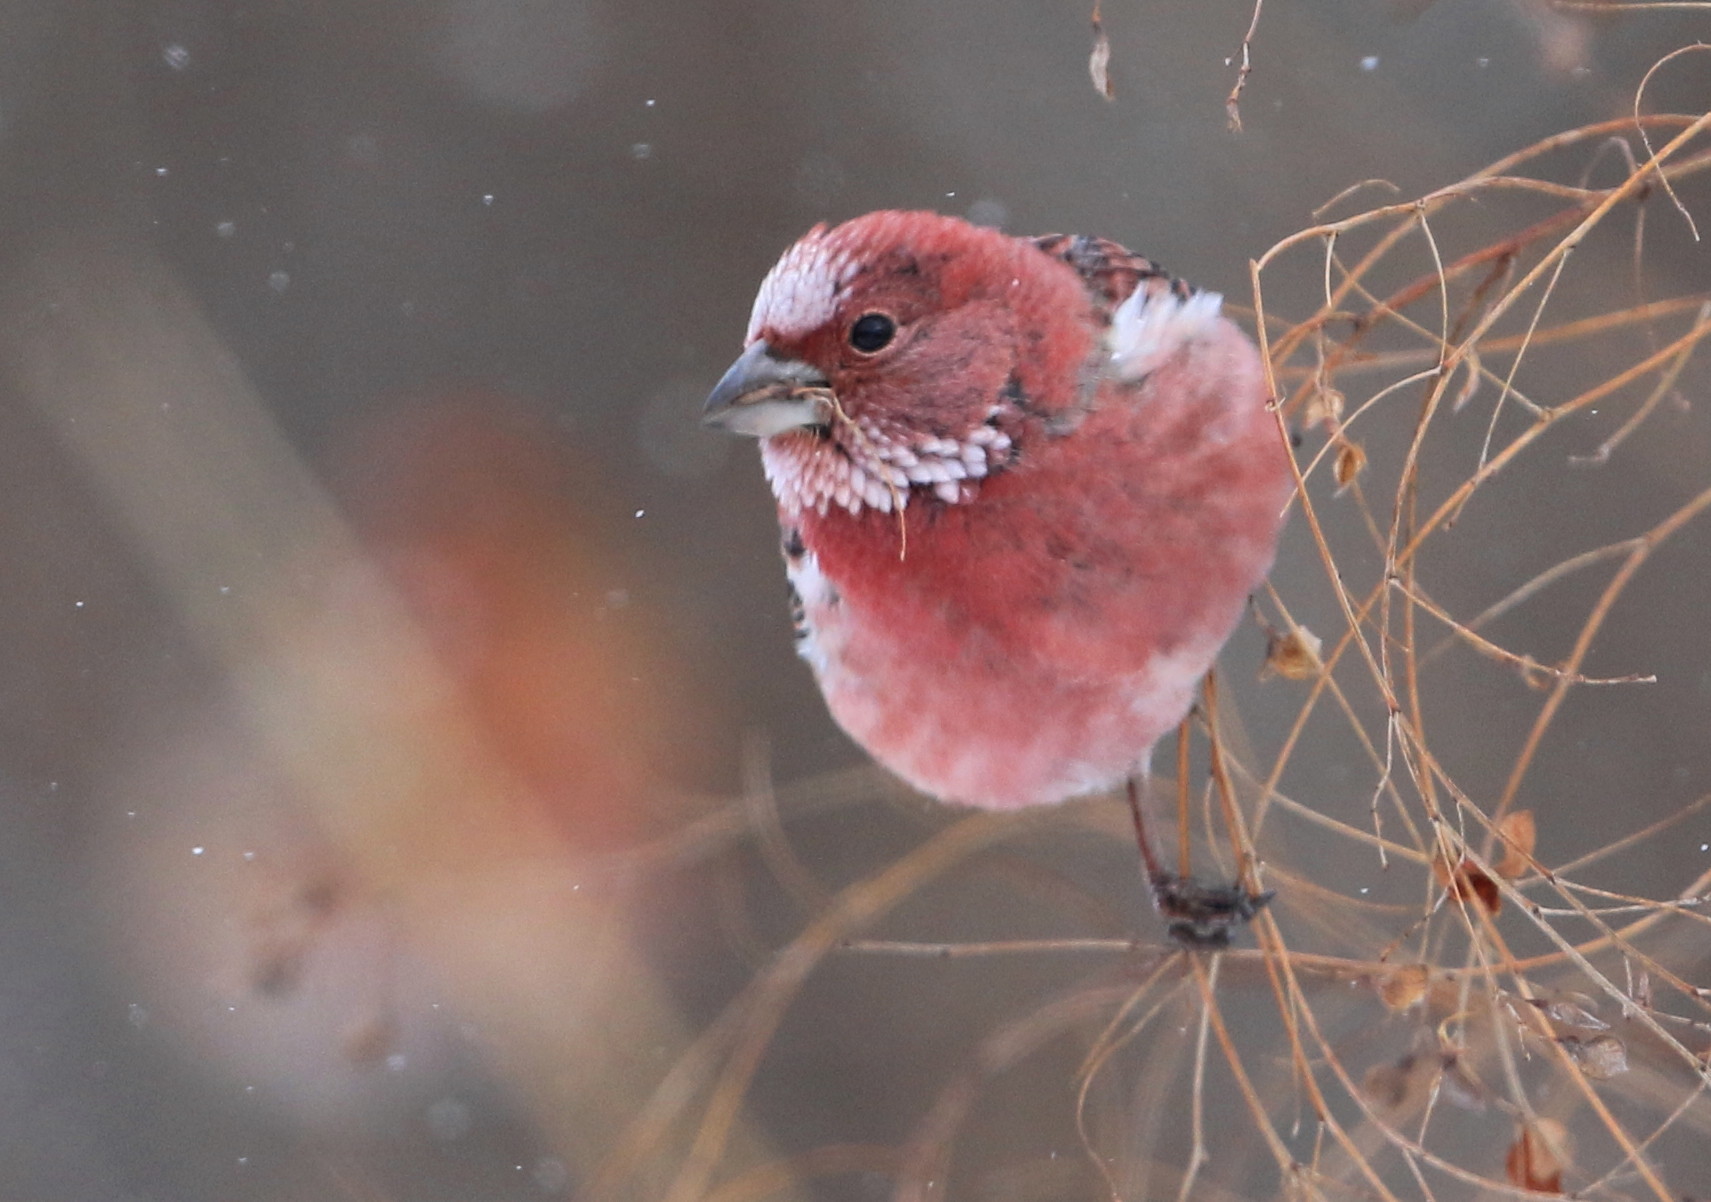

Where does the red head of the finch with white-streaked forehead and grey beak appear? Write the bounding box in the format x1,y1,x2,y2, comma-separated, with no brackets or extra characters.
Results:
703,212,1098,513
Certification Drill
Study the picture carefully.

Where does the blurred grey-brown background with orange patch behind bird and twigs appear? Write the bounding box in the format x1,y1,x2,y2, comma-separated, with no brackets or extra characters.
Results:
0,0,1711,1202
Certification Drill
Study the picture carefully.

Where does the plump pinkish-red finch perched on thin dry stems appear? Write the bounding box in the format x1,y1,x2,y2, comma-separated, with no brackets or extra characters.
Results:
705,212,1294,944
